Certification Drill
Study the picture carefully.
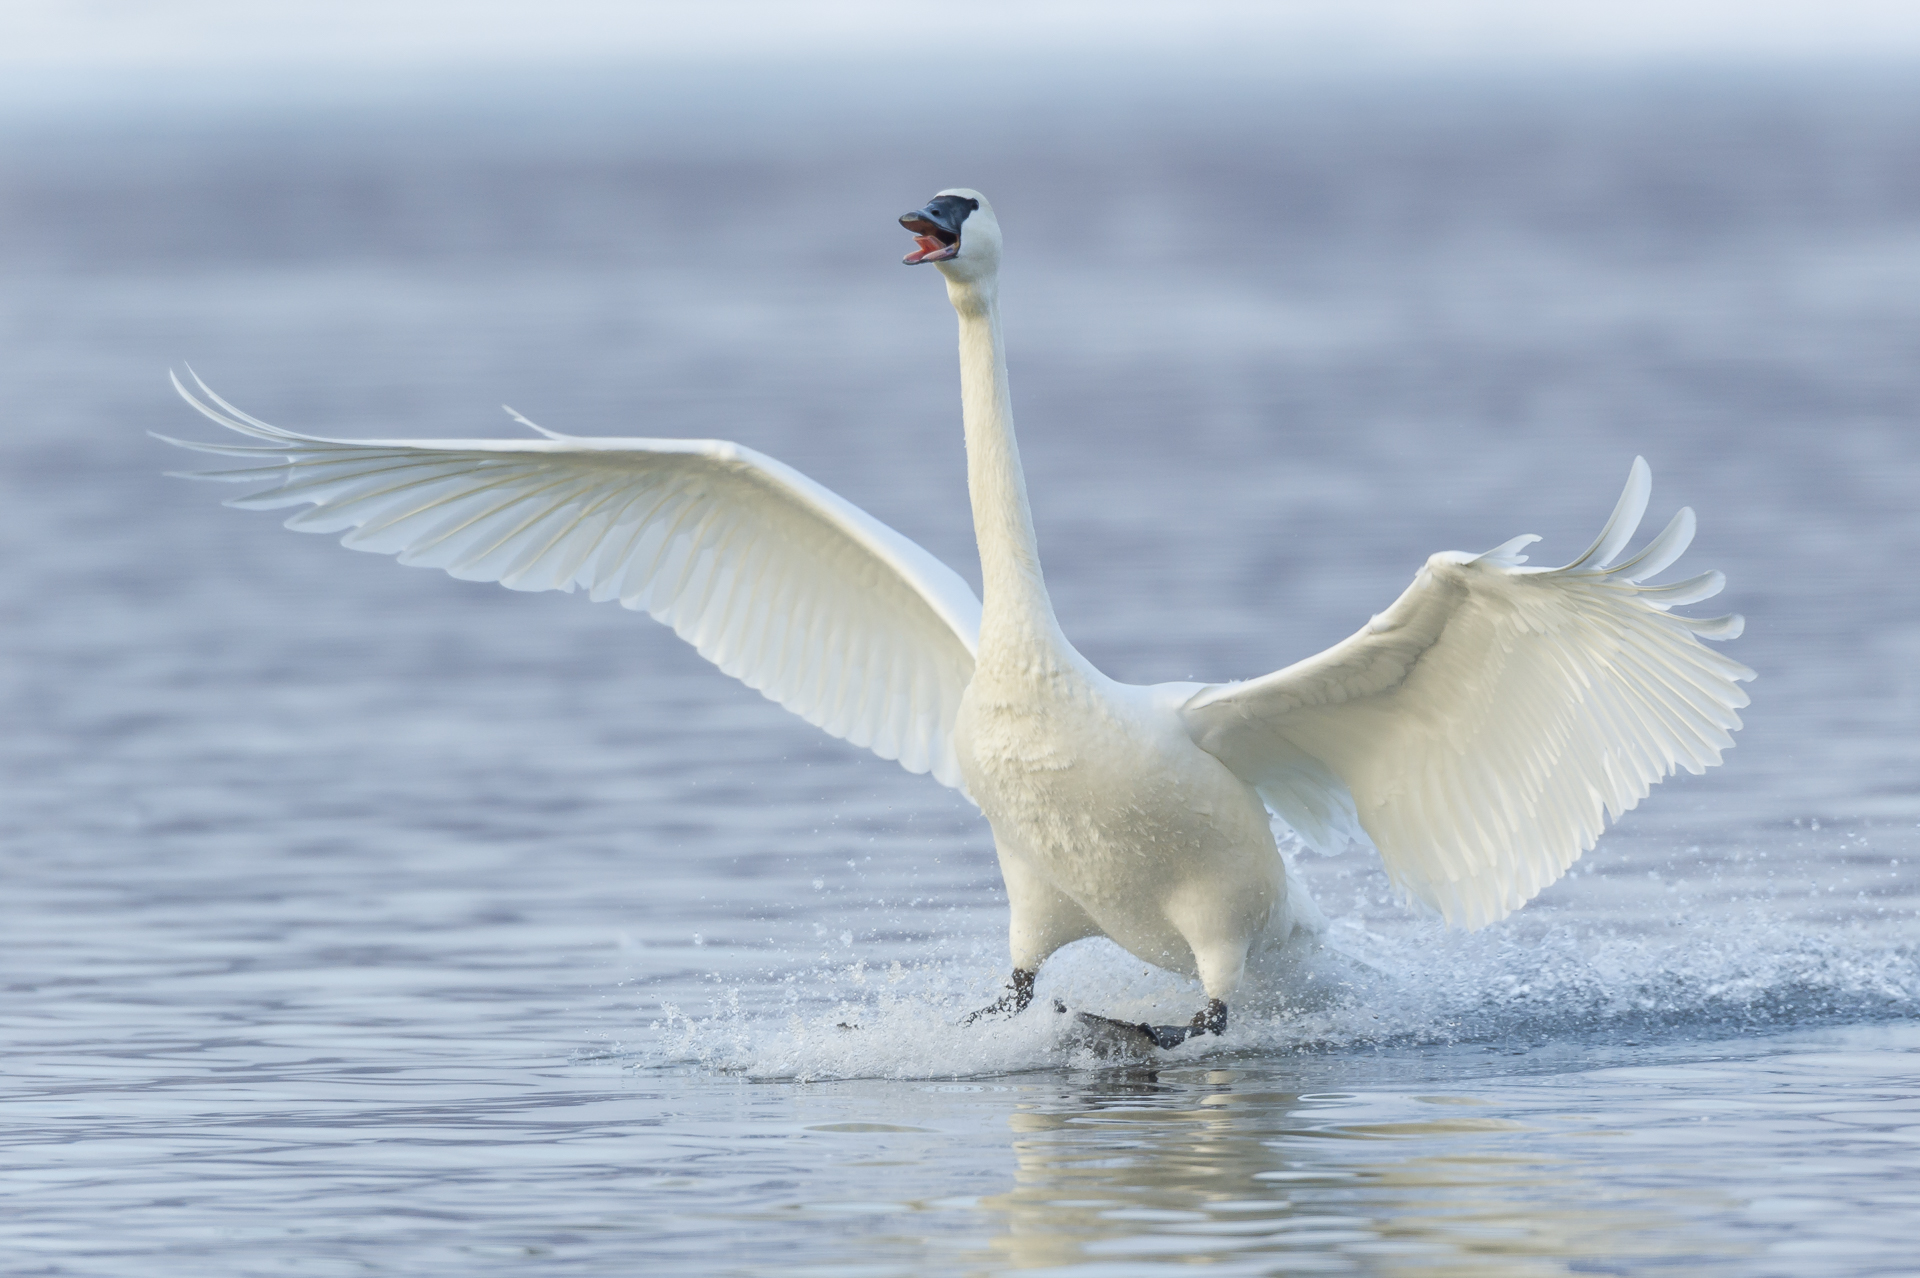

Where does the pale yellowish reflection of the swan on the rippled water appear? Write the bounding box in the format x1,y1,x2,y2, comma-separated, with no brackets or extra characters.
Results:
977,1071,1724,1278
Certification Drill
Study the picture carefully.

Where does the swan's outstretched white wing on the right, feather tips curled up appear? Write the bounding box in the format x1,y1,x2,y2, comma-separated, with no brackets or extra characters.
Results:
1181,457,1753,927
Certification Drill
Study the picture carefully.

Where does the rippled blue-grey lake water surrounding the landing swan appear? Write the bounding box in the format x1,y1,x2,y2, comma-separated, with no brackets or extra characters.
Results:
0,62,1920,1278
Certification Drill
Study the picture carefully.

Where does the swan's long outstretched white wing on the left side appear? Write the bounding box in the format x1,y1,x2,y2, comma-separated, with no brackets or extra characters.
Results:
161,378,979,789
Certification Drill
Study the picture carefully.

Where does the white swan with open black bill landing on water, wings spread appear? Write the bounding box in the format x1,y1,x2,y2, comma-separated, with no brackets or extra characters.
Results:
161,188,1753,1048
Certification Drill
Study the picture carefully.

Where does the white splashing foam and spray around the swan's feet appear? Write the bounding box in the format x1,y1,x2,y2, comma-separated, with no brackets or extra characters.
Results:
630,901,1920,1078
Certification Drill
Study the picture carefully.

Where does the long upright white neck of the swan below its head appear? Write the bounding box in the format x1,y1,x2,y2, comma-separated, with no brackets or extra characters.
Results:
947,278,1079,666
